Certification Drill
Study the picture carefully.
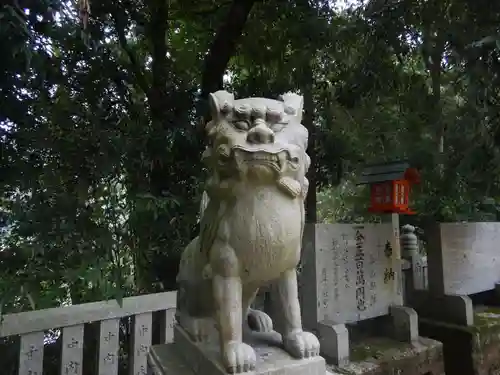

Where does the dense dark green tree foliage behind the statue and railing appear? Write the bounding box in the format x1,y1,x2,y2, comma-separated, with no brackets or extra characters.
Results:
0,0,500,318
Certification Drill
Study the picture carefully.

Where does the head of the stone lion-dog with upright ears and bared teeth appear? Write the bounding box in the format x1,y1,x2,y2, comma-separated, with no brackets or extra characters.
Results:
203,91,310,197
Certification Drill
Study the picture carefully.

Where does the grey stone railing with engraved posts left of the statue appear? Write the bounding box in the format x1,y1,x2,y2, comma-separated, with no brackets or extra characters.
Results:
0,292,176,375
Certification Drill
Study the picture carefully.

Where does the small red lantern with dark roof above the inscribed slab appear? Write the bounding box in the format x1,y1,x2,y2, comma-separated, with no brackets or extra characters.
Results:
360,162,420,215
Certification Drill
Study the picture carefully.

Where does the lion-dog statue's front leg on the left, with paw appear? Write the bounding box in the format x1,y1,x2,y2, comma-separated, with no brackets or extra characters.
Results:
210,241,257,374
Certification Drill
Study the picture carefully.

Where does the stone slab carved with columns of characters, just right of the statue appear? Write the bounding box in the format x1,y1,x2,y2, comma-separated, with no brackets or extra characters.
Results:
301,224,398,325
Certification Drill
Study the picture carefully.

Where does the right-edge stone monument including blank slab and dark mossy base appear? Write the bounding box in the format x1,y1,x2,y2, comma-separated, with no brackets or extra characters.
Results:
408,222,500,375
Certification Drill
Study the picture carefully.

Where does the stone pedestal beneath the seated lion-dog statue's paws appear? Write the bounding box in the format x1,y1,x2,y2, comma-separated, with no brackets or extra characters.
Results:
148,325,327,375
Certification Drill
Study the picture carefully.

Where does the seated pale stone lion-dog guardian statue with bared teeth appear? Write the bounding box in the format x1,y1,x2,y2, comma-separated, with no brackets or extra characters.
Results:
177,91,319,373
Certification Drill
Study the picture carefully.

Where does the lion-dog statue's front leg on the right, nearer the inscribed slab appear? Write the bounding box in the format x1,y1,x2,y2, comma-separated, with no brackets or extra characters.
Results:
273,268,319,358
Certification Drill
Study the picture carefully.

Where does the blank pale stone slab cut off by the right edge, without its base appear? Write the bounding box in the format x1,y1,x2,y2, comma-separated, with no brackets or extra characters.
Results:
441,223,500,295
